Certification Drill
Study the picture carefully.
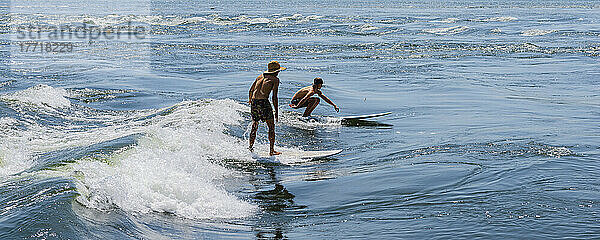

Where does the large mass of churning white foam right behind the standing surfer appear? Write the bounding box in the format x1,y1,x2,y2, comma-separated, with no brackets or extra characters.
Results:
73,100,256,218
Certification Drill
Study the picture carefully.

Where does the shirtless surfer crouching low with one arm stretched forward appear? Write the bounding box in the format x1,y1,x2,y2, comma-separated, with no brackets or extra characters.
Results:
290,78,340,117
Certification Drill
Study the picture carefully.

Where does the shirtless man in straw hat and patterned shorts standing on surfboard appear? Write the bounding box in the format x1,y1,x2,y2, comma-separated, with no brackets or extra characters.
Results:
248,61,286,156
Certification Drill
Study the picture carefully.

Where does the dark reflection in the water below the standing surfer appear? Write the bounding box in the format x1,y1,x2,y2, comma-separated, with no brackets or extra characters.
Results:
254,166,305,239
